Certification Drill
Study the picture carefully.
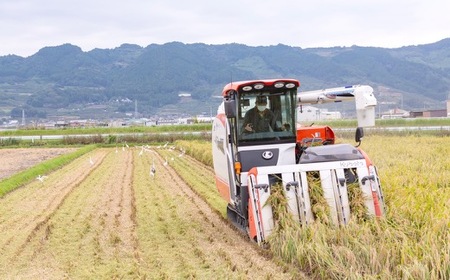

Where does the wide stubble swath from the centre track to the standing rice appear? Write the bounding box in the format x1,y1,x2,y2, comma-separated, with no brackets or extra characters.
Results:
137,149,302,279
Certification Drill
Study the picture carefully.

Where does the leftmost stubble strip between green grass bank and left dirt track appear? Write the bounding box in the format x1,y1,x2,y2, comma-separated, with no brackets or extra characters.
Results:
0,150,106,261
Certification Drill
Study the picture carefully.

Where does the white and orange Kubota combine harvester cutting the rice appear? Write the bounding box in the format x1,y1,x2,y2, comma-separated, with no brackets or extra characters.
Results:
212,79,384,244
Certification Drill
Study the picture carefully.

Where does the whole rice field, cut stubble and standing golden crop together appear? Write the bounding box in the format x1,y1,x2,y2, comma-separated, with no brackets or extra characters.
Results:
0,135,450,279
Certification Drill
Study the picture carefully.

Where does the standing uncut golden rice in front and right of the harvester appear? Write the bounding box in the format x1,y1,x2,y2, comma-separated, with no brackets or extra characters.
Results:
175,135,450,279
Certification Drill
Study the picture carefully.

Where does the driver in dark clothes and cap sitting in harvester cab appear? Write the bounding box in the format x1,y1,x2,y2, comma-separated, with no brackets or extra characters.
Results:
243,96,275,133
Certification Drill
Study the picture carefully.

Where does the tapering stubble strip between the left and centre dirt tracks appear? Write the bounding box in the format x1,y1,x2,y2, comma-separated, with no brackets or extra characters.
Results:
1,149,139,279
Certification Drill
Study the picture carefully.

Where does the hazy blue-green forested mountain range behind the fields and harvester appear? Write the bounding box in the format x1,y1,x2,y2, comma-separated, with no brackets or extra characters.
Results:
0,38,450,119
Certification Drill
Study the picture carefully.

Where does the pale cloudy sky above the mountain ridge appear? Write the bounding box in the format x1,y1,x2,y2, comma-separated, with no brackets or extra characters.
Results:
0,0,450,57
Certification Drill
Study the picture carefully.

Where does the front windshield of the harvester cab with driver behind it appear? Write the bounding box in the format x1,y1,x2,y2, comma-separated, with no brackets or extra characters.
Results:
237,90,297,144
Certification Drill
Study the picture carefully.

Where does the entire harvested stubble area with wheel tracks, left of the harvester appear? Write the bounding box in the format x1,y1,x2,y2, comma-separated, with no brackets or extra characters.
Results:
0,148,301,279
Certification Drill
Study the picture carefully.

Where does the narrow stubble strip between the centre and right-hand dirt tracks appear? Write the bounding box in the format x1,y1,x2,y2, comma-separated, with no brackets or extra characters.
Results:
135,149,234,279
